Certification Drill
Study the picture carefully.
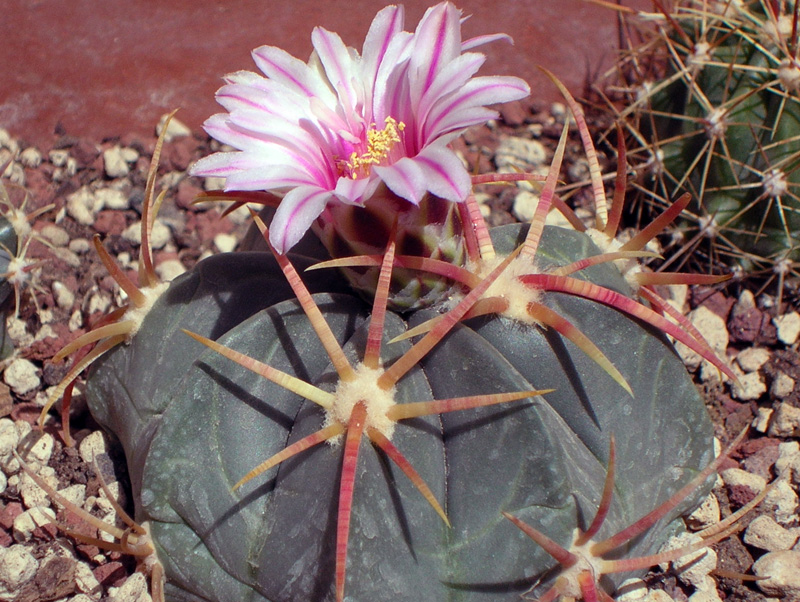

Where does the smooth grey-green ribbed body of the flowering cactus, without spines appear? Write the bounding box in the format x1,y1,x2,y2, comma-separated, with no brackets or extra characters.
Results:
87,225,712,601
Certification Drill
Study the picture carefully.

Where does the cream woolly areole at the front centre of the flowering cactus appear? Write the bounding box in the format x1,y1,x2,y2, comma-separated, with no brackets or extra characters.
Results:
325,364,396,443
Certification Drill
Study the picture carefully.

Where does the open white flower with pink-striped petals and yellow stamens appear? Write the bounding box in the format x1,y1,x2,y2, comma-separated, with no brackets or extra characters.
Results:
191,2,529,253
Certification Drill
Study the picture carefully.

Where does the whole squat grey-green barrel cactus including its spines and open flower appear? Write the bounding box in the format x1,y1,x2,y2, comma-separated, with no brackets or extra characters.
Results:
36,3,729,602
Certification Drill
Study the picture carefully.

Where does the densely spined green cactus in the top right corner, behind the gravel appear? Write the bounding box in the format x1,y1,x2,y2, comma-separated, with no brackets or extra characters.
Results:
617,0,800,291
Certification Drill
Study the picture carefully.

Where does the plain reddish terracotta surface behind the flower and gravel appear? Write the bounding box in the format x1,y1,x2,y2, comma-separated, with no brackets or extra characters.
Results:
0,0,641,148
